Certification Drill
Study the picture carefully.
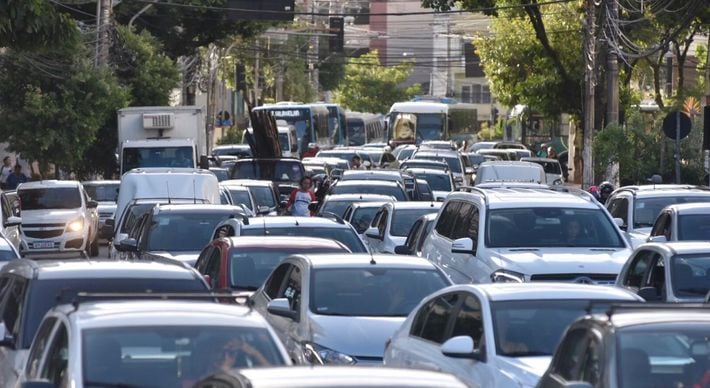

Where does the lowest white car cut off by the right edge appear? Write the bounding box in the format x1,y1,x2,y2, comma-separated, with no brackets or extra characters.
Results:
616,241,710,302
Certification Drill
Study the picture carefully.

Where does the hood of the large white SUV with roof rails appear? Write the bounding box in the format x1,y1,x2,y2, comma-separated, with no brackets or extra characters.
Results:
494,248,631,275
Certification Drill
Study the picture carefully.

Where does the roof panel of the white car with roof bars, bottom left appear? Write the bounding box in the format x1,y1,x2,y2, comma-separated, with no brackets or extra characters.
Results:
54,299,267,328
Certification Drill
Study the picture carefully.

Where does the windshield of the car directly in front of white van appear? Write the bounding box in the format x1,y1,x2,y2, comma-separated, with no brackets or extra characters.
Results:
146,210,237,252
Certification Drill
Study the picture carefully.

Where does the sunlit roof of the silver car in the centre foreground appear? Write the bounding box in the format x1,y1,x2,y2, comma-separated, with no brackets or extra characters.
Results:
291,253,436,270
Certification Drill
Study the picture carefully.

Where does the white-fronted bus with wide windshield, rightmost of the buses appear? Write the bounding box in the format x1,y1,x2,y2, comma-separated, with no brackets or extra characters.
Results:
387,101,479,147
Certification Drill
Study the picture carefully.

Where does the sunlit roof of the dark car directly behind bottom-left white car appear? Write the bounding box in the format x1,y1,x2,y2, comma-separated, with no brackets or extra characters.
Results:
1,259,195,279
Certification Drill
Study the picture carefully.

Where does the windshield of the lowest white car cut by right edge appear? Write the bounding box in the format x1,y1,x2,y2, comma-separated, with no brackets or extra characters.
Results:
671,254,710,299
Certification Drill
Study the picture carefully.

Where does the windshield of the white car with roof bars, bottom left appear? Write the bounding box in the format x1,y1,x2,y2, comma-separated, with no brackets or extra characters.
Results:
82,320,285,388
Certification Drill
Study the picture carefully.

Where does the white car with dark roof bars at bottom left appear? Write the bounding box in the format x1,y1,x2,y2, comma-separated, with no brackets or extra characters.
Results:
22,294,290,388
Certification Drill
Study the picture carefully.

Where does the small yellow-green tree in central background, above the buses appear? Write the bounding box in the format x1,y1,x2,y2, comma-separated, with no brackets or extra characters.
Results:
334,50,421,113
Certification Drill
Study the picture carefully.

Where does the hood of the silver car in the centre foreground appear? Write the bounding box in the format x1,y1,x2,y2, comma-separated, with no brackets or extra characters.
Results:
311,314,406,358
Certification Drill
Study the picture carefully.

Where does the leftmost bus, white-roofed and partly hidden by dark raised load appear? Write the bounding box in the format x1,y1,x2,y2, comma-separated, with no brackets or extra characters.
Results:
253,103,334,158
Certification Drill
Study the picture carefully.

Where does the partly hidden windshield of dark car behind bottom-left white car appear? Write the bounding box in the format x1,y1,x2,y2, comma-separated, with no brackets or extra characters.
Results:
20,277,206,349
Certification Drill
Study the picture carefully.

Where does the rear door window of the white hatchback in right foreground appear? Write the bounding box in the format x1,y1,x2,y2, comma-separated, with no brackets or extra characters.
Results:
410,294,461,344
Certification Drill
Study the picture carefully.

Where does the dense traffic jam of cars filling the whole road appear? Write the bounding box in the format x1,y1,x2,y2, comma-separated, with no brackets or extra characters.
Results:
0,142,710,388
